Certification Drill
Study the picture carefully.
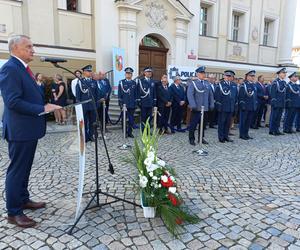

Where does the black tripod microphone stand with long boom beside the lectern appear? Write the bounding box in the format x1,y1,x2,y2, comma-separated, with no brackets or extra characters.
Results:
47,62,141,235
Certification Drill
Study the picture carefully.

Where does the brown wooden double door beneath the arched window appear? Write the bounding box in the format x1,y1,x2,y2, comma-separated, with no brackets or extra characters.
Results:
139,46,168,80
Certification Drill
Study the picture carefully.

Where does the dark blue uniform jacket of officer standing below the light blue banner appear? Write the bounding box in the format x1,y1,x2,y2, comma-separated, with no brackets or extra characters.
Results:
118,79,137,109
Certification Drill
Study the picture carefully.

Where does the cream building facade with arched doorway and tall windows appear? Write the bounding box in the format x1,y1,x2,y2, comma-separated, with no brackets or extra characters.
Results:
0,0,297,82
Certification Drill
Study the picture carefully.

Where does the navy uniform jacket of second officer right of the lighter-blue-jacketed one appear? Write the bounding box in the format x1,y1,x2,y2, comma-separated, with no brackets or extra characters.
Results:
238,81,257,111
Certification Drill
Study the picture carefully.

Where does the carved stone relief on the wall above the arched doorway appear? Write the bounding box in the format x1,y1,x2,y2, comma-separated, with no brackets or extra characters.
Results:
145,1,168,29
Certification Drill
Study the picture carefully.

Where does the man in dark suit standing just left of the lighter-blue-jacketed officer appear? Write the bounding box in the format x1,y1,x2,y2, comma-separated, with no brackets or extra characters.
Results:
170,76,186,133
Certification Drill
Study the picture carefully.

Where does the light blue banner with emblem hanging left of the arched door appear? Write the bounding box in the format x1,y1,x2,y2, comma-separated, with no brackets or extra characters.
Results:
113,47,125,94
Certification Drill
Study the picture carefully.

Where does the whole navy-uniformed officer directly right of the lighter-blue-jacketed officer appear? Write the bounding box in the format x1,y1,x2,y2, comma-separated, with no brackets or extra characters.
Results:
215,70,238,143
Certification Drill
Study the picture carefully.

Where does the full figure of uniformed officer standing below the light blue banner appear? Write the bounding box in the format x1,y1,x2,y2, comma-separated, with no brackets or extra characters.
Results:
118,67,137,138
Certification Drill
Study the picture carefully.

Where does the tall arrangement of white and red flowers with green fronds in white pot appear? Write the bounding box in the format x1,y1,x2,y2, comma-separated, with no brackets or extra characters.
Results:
130,121,199,235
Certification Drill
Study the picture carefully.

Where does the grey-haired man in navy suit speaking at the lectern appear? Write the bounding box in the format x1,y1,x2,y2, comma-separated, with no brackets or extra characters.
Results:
0,35,61,227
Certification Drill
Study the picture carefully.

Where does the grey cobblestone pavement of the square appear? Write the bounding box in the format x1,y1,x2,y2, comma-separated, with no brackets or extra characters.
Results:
0,126,300,250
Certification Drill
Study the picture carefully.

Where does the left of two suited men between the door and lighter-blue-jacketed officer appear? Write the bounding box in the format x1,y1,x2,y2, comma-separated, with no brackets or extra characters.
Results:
157,74,172,134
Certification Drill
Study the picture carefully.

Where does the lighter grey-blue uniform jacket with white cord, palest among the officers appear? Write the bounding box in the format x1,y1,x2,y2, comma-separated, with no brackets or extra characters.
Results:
187,79,214,111
